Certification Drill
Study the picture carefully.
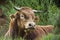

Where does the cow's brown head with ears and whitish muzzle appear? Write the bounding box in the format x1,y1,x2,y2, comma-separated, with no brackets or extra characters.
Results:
11,7,38,29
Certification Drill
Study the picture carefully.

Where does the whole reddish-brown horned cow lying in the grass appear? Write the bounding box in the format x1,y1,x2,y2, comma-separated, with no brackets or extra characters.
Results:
5,7,53,40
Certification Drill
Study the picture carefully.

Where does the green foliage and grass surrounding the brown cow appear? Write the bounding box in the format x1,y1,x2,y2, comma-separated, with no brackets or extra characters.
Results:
0,0,60,40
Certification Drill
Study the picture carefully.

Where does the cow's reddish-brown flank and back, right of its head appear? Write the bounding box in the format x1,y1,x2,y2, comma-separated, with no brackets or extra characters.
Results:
25,25,53,40
